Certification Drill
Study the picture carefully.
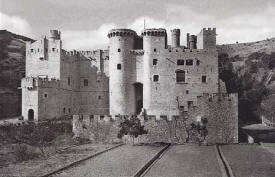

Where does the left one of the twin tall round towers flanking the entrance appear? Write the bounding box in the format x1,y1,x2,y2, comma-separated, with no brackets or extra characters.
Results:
108,29,136,115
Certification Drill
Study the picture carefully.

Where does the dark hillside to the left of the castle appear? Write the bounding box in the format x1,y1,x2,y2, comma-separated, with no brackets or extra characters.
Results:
0,30,33,119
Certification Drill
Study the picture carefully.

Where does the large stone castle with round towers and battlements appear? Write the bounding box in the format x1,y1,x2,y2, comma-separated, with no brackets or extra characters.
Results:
21,28,238,142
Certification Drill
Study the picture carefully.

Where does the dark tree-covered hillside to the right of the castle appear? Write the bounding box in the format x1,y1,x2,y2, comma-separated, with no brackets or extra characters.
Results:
217,38,275,126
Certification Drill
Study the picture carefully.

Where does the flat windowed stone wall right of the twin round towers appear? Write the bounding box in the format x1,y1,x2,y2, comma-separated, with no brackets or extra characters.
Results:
144,49,218,115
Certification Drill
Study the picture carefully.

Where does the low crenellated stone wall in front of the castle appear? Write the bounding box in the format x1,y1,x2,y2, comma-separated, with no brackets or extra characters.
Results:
73,94,238,143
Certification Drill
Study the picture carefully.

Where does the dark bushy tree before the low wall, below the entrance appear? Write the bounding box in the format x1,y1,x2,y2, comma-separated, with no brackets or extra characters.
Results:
117,116,147,144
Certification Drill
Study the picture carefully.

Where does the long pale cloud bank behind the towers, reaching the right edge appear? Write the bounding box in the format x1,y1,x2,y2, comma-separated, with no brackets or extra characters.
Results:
63,4,275,50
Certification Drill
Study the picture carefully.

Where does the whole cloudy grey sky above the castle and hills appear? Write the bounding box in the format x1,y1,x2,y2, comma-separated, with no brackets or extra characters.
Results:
0,0,275,50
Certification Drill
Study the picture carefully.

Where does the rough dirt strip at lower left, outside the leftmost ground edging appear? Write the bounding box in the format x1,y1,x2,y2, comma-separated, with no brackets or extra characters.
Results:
0,144,115,177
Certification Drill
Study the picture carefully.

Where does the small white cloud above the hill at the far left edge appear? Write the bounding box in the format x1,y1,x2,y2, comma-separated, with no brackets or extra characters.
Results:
0,12,34,37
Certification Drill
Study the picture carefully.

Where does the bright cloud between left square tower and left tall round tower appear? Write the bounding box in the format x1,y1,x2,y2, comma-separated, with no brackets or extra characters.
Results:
61,24,116,50
